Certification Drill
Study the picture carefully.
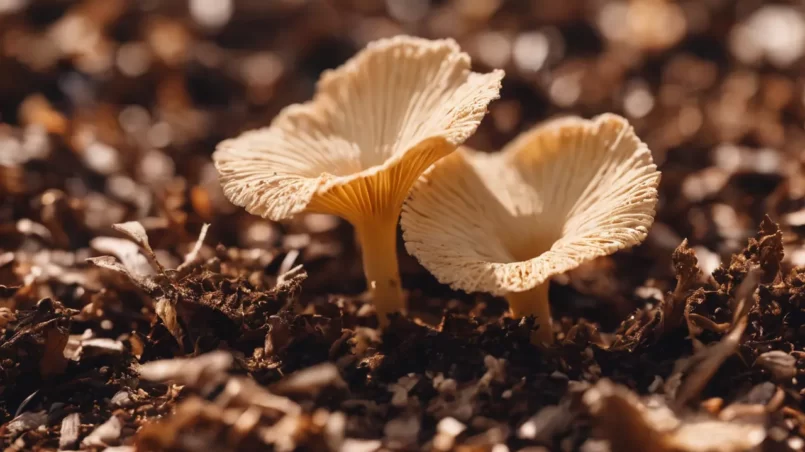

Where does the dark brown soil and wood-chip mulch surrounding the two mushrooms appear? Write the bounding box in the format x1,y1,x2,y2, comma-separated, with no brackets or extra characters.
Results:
0,0,805,452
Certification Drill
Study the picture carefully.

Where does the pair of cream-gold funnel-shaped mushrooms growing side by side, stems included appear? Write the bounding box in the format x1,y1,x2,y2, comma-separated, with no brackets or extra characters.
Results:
213,36,659,342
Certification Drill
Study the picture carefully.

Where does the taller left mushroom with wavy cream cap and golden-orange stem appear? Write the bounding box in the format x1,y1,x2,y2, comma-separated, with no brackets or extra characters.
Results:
213,36,503,324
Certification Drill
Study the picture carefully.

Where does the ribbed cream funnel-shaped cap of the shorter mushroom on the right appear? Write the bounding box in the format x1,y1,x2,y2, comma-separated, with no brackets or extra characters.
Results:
401,114,660,295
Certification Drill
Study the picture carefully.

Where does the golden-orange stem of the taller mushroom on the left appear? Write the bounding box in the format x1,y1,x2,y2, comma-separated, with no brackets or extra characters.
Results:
355,216,405,327
